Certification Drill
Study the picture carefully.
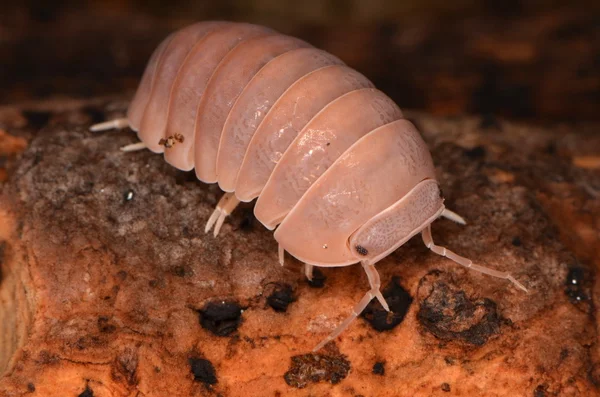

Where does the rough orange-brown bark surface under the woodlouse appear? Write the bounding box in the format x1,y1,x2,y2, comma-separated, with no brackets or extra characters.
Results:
0,100,600,397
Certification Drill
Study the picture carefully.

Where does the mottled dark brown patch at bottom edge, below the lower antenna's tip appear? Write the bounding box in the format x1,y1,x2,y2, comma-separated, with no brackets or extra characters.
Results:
283,353,350,389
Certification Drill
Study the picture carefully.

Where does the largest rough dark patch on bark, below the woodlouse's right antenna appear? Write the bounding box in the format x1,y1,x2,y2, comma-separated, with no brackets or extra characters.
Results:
417,271,506,346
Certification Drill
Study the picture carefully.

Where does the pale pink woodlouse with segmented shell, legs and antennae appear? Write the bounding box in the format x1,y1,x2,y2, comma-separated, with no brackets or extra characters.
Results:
91,22,527,350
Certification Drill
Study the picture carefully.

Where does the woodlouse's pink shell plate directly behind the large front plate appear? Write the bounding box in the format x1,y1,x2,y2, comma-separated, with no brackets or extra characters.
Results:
254,88,402,229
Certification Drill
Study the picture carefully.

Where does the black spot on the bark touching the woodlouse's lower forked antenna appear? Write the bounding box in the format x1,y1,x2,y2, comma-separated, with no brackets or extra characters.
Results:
361,277,412,332
